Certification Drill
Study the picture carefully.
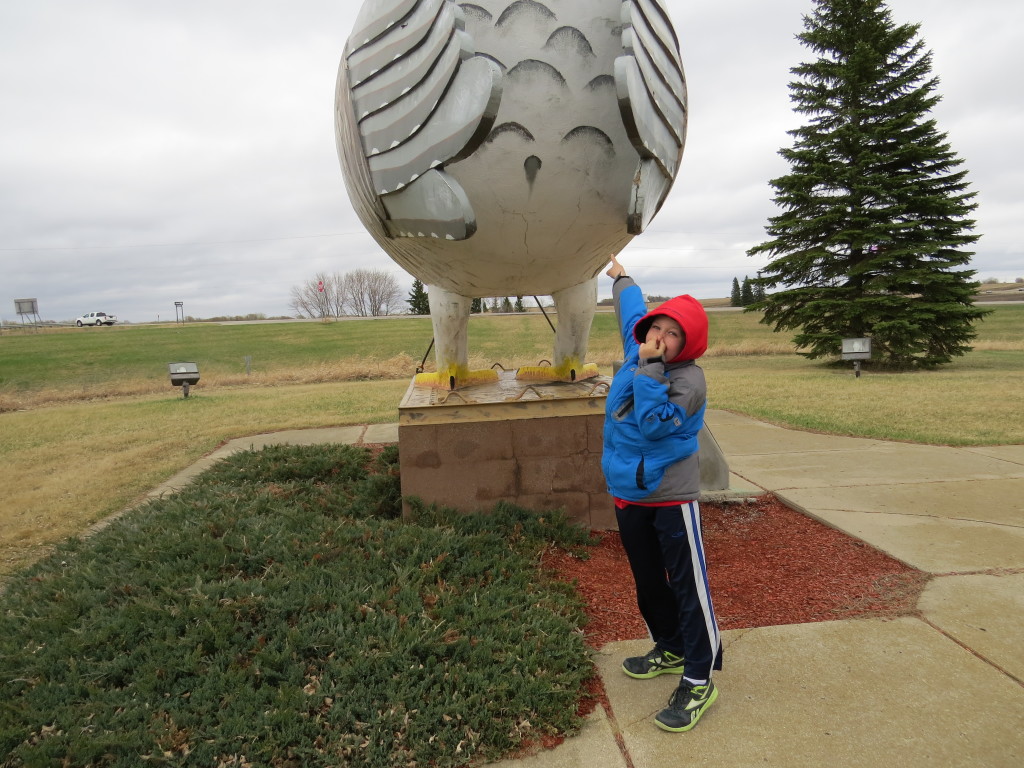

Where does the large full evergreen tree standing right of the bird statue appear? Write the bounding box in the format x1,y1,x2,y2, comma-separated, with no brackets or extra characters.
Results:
748,0,986,367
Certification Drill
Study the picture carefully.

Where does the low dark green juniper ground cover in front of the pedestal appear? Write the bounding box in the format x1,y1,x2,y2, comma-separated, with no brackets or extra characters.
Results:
0,445,592,768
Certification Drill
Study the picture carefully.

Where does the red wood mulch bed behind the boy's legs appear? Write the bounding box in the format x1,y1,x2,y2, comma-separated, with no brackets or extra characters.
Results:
544,496,928,648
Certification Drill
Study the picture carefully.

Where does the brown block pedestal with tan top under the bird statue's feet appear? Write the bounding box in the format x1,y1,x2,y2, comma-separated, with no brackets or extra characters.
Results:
398,372,615,529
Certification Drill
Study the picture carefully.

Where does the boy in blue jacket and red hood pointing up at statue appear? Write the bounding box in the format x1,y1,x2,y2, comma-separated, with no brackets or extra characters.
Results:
601,256,722,732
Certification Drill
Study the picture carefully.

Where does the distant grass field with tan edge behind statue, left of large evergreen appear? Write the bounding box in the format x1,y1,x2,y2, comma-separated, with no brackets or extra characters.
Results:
0,311,792,412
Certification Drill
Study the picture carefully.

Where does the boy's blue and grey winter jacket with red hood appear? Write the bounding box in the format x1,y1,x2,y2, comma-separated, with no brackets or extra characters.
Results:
601,276,708,504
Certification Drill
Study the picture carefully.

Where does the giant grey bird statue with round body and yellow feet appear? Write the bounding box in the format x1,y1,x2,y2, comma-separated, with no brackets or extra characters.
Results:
335,0,686,388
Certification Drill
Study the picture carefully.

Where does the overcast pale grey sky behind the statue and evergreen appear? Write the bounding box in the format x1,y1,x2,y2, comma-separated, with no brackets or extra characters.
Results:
0,0,1024,323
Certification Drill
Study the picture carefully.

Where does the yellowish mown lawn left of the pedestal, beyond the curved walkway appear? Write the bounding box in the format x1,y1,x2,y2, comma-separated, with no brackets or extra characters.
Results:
0,380,409,574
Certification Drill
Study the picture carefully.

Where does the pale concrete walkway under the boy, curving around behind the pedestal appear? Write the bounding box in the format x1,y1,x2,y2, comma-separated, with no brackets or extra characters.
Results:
146,411,1024,768
